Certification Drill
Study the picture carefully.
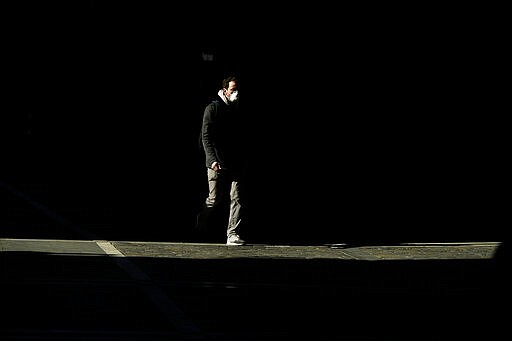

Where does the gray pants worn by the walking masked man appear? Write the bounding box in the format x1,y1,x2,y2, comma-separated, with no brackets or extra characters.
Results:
205,168,242,236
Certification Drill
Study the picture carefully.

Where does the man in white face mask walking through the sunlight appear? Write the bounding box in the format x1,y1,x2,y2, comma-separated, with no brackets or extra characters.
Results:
197,76,247,245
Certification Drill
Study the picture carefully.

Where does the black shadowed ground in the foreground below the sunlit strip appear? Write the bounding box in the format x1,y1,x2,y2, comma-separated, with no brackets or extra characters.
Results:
0,248,508,340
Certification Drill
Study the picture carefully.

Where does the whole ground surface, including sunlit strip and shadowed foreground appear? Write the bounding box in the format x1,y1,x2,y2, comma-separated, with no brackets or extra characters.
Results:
0,179,510,341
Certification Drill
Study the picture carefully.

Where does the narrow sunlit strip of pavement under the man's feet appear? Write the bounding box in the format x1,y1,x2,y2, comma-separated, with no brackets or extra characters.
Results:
0,238,502,261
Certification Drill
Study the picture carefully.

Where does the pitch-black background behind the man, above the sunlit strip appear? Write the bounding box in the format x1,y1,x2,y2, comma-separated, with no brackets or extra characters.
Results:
2,1,506,243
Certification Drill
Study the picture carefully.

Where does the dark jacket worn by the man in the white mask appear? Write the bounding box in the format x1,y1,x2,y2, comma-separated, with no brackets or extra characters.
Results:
201,98,247,169
